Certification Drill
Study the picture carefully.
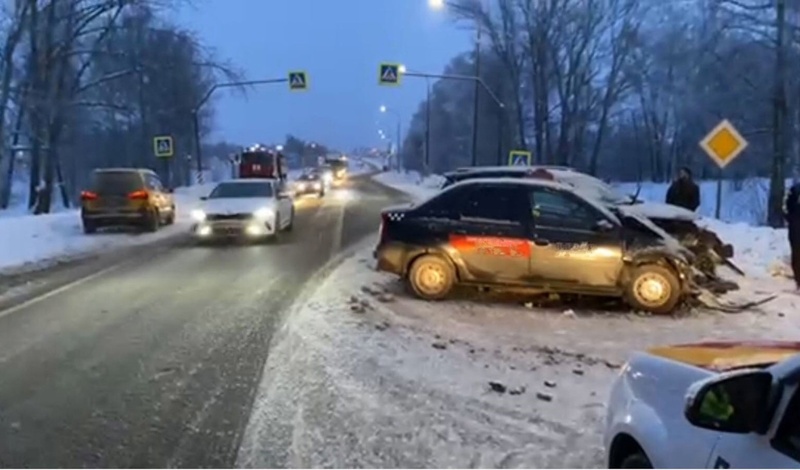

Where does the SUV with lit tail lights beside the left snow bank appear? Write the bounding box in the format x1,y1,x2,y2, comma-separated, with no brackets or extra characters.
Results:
81,168,175,233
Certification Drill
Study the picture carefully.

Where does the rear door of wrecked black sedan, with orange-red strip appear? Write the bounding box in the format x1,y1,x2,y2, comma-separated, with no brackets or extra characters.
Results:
448,183,530,284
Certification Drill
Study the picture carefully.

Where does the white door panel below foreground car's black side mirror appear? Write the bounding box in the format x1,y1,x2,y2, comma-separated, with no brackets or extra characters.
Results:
706,386,800,468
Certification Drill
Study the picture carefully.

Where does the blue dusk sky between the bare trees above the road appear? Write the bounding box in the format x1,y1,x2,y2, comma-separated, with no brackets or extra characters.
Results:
179,0,471,149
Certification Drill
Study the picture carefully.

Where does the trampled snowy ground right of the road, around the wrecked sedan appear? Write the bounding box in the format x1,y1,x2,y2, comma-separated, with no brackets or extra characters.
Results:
237,168,800,468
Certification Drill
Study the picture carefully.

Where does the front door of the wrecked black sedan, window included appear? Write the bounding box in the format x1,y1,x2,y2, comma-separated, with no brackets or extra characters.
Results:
528,186,623,288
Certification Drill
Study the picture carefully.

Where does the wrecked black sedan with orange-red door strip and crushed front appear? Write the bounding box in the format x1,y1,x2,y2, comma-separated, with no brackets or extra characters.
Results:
374,178,693,314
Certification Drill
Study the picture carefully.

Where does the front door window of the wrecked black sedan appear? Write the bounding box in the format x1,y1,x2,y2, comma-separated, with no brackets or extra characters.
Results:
530,188,602,230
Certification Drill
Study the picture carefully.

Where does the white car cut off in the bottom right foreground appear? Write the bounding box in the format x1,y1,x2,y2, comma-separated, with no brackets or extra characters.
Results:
604,341,800,468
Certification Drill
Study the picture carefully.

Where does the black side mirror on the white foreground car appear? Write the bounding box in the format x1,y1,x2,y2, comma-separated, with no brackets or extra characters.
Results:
684,369,772,434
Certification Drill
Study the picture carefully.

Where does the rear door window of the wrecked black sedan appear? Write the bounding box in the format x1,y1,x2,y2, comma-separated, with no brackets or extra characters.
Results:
459,186,524,224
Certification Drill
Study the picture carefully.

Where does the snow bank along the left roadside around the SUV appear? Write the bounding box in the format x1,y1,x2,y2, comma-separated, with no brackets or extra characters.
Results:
0,183,216,271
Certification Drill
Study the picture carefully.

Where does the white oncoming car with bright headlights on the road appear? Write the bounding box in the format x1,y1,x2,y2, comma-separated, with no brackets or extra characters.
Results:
192,178,294,240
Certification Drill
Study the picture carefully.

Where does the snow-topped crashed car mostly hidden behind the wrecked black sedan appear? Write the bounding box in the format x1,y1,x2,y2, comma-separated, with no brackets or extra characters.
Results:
442,166,741,278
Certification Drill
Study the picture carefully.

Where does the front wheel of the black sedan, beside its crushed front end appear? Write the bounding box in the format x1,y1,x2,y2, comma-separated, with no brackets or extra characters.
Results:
625,264,681,315
